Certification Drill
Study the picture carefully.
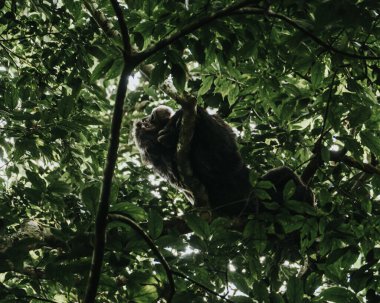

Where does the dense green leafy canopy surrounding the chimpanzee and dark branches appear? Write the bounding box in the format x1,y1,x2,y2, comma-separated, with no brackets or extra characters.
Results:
0,0,380,303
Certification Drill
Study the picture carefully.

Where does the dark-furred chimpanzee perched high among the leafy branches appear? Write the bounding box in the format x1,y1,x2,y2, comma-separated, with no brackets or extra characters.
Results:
134,105,309,216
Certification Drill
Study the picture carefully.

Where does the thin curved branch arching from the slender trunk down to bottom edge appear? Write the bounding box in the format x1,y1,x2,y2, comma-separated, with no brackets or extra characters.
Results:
108,214,175,302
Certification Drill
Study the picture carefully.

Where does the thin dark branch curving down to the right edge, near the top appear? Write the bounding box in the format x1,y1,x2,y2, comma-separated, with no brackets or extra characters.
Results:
235,7,380,60
